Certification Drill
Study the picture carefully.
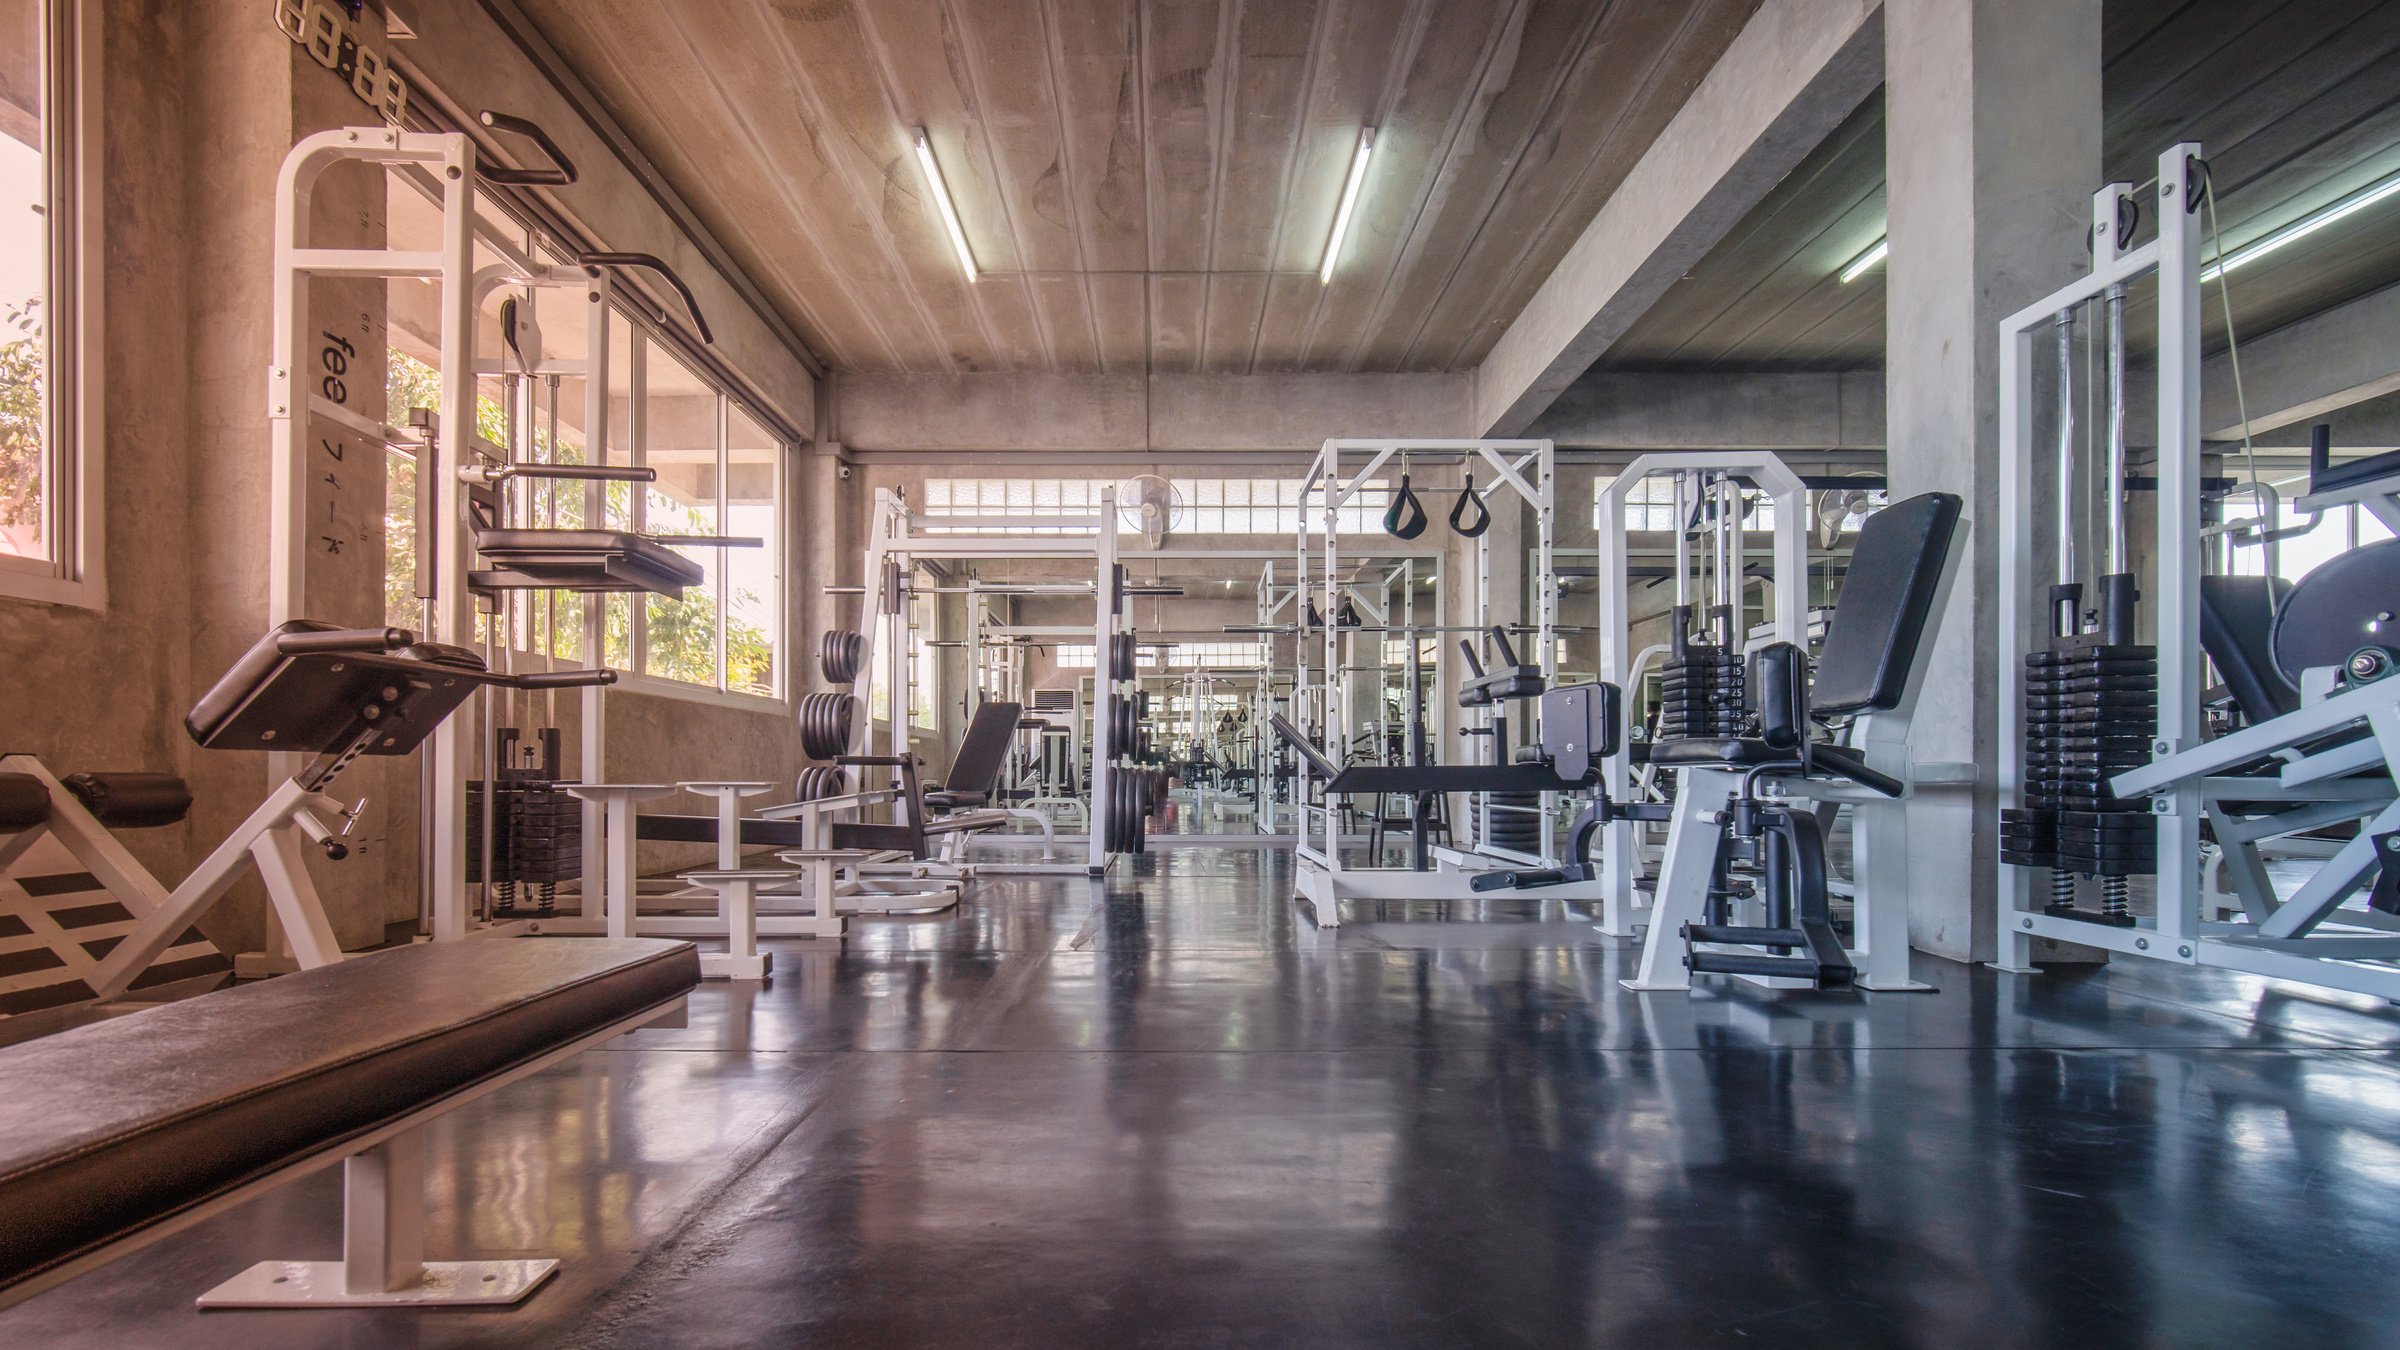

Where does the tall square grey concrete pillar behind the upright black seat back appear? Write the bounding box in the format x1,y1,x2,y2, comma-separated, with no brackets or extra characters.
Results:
1884,0,2100,961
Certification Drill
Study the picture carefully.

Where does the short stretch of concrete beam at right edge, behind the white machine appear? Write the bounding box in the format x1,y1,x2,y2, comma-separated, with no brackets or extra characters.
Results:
2201,286,2400,444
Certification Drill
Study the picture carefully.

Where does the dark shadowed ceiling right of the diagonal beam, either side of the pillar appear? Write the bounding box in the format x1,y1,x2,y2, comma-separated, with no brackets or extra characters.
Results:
1596,0,2400,370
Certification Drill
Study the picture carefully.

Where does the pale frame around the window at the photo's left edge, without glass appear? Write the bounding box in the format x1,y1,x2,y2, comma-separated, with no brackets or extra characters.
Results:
0,0,108,610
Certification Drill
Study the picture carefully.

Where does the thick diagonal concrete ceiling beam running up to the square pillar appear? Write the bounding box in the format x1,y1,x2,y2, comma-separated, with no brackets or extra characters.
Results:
1474,0,1884,435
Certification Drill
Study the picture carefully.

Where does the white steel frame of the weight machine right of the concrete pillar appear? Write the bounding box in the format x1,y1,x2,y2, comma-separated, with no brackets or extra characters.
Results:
1997,142,2400,999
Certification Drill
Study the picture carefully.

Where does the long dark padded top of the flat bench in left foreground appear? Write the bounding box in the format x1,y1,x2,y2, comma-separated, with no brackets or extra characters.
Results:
0,937,701,1288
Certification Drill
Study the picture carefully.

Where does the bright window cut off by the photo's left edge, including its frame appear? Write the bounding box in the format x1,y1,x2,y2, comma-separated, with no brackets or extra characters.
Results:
0,0,96,601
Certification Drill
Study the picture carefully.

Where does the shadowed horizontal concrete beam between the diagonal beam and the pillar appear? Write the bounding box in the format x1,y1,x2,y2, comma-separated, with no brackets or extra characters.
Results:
1524,370,1884,452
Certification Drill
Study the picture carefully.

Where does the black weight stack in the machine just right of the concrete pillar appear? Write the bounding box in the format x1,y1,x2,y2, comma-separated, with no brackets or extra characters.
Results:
1999,577,2158,927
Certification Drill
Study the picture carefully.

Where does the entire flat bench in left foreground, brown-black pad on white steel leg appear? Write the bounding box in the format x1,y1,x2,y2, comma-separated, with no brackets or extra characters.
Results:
0,939,701,1307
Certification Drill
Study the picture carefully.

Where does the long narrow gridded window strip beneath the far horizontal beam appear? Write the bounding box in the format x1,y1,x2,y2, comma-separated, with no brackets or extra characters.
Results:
917,478,1392,536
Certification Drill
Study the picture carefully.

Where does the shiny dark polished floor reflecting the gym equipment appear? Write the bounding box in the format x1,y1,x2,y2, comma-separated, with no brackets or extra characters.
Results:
0,848,2400,1350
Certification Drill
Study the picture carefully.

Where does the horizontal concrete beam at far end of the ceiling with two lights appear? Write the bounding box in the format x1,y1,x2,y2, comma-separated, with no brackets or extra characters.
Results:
835,375,1469,456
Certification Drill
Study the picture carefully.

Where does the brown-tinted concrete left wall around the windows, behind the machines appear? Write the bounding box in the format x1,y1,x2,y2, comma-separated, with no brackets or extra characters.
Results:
0,0,842,949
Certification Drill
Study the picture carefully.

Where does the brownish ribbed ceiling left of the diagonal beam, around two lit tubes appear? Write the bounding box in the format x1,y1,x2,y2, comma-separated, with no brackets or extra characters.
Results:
518,0,1759,375
